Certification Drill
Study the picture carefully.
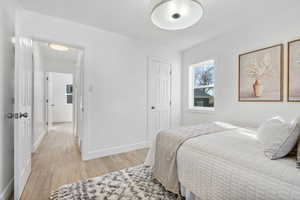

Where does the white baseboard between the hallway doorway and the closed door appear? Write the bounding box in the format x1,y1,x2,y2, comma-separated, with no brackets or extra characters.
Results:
83,141,149,160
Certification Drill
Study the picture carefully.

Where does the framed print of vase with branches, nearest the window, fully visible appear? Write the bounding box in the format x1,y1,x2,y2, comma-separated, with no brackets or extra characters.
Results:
239,44,283,102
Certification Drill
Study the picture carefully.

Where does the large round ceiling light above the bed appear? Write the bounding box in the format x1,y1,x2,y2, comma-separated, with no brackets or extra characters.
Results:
151,0,203,30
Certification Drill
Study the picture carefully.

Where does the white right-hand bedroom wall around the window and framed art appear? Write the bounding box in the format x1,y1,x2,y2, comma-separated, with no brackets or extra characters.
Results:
182,5,300,125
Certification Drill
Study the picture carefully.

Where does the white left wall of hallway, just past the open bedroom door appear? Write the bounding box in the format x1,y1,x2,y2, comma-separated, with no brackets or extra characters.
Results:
32,42,46,152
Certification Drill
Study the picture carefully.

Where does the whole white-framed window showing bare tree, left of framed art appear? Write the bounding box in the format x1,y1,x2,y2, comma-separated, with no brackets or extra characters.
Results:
189,60,215,110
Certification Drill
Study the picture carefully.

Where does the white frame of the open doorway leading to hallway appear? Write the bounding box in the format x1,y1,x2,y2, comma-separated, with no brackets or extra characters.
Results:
31,36,89,160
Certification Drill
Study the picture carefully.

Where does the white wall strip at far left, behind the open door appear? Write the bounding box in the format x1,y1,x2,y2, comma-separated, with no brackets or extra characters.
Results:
0,0,16,200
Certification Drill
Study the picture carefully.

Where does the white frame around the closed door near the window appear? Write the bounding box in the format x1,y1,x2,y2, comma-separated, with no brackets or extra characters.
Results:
146,56,173,143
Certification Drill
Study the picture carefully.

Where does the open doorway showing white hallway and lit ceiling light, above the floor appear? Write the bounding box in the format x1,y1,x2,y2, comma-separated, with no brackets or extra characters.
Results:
32,41,83,152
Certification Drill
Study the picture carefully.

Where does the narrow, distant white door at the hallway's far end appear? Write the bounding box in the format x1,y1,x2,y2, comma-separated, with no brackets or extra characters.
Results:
46,73,55,131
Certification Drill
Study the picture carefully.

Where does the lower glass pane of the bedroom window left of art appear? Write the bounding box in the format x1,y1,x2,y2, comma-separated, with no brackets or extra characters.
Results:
194,87,215,107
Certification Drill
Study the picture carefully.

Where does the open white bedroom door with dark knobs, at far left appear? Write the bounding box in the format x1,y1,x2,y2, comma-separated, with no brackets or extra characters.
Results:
14,37,33,200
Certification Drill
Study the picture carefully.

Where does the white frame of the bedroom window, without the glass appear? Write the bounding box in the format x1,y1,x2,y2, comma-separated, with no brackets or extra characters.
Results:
188,59,216,113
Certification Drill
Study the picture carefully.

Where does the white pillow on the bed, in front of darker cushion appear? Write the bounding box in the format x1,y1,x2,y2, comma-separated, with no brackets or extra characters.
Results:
257,117,300,160
